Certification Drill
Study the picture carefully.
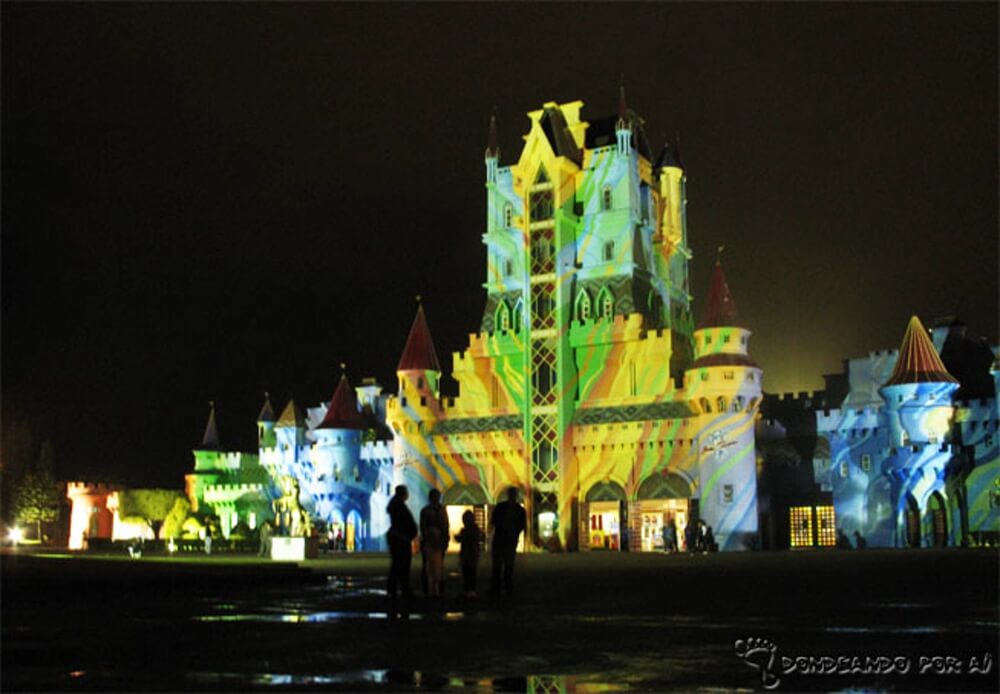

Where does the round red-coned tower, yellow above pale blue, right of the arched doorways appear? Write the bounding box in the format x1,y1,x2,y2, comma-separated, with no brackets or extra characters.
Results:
685,262,762,550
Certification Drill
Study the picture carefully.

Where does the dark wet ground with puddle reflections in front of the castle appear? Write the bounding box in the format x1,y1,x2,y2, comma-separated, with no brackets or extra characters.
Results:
2,550,1000,692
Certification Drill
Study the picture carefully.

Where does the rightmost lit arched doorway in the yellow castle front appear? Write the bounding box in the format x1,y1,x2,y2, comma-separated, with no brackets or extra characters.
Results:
632,471,697,552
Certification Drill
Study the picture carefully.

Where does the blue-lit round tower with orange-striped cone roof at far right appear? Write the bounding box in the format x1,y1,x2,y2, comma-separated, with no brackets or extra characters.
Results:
879,316,958,547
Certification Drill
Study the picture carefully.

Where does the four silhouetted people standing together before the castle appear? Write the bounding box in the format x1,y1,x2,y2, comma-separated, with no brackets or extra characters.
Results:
386,485,525,598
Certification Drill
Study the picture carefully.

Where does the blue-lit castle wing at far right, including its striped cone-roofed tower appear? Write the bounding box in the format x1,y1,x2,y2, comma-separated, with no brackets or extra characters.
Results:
815,316,1000,547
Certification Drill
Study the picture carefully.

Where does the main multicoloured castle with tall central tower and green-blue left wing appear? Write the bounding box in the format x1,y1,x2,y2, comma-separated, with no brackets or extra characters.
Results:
188,91,761,550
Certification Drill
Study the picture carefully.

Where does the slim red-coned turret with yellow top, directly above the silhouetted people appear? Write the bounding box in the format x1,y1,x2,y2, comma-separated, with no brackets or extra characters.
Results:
386,304,441,504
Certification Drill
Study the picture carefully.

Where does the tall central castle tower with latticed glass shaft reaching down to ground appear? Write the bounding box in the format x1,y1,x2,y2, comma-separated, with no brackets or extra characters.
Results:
482,90,691,542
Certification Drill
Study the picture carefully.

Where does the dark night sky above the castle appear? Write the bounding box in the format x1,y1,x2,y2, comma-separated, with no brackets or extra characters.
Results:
2,2,998,487
